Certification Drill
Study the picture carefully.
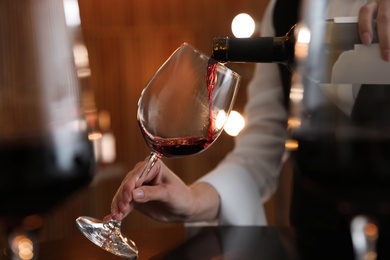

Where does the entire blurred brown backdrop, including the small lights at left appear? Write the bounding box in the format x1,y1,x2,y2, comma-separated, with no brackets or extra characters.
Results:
42,0,290,242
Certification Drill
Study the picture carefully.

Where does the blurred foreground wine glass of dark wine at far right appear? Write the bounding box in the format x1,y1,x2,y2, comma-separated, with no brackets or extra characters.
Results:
290,0,390,259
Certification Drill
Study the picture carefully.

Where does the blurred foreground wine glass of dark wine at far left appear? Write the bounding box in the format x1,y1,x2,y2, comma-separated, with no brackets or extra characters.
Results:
0,0,95,259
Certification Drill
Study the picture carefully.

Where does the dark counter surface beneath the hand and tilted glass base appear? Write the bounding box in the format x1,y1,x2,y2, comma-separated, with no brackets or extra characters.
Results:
21,223,390,260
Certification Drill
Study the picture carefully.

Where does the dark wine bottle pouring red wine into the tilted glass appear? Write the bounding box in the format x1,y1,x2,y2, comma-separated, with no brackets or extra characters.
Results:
211,19,378,67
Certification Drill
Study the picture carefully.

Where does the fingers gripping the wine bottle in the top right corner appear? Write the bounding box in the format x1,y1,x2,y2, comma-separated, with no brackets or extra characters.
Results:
358,0,390,61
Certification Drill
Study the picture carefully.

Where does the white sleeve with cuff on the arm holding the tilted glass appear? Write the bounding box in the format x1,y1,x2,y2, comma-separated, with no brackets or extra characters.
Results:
198,1,287,225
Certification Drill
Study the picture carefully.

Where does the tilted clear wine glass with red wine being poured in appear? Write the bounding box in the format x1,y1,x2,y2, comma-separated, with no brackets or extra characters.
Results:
76,43,241,258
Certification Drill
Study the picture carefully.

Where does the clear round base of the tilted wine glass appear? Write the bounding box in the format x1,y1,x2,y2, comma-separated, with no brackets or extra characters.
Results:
76,216,138,259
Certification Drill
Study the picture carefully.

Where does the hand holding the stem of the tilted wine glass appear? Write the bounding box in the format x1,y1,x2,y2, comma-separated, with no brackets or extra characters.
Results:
104,156,220,222
